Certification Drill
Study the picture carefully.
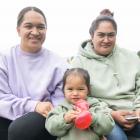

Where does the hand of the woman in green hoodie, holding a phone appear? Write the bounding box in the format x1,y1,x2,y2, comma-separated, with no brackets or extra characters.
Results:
111,110,137,130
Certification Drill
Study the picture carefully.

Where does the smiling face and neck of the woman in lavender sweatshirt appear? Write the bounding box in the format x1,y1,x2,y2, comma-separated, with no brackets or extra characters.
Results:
17,11,46,53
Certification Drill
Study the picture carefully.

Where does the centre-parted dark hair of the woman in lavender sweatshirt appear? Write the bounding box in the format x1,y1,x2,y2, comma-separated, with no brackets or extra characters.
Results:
17,7,47,27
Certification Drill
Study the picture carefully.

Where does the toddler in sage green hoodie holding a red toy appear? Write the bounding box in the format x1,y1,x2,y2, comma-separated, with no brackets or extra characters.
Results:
45,68,114,140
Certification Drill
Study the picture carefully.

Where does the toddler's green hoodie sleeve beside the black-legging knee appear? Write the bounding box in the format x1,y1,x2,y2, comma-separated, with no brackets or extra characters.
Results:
45,106,73,137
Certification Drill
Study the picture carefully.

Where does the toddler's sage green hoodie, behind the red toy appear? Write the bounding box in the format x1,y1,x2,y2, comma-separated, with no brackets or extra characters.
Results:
45,97,114,140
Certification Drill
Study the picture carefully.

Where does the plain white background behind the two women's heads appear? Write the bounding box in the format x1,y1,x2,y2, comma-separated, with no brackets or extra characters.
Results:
0,0,140,57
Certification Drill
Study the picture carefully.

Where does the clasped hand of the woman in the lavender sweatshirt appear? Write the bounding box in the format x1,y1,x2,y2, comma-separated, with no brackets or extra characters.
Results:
35,102,53,117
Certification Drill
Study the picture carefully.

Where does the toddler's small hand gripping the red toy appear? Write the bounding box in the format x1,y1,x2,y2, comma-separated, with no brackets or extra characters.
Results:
64,110,80,123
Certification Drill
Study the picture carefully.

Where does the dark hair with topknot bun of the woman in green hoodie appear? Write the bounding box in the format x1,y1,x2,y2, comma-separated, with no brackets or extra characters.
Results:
89,9,117,37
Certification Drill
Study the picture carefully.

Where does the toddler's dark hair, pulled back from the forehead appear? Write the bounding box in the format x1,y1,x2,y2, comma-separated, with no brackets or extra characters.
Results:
62,68,90,92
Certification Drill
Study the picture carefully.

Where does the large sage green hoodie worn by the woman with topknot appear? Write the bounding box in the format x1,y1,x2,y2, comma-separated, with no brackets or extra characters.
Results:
71,41,140,110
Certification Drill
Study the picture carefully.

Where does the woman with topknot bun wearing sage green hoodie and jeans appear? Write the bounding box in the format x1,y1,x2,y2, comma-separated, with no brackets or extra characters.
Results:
72,9,140,140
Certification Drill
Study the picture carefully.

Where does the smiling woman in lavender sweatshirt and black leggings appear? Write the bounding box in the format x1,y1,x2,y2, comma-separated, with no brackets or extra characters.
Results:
0,7,67,140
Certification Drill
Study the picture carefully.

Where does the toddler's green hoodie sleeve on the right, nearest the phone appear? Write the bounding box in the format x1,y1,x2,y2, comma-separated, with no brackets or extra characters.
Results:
90,99,115,136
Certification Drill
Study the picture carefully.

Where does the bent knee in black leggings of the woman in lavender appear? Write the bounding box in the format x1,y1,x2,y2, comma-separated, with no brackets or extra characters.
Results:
0,112,56,140
